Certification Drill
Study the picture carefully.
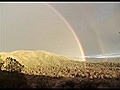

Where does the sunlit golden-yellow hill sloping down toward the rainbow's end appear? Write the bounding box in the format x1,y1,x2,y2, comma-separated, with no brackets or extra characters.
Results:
0,50,85,74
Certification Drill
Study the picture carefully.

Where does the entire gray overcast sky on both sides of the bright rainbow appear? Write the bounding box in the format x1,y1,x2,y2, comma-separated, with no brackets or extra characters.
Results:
0,3,120,56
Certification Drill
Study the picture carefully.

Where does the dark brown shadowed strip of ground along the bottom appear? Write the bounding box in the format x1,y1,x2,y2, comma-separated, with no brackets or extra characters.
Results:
0,71,120,88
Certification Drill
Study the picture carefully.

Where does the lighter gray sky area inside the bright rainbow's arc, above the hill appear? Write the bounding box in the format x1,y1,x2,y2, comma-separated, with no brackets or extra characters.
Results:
0,4,84,56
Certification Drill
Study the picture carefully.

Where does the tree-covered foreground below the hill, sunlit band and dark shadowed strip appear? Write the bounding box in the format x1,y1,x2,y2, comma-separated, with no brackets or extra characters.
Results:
0,50,120,88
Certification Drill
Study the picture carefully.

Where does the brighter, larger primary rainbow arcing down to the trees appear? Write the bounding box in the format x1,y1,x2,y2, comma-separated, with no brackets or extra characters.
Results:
46,3,86,61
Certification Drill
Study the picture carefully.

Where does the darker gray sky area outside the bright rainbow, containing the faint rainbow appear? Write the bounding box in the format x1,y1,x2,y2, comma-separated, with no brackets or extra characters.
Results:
51,3,120,55
